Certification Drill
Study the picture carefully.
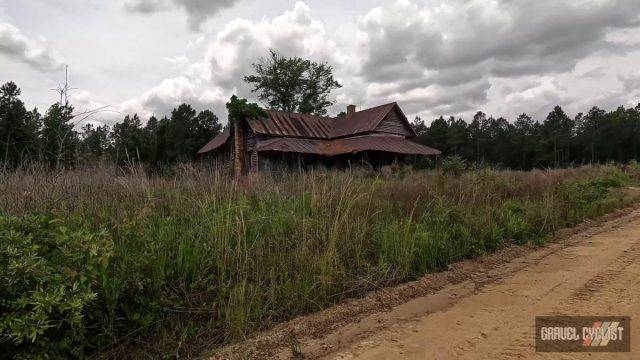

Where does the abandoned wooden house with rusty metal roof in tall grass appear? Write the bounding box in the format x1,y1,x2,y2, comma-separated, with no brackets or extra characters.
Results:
199,103,440,172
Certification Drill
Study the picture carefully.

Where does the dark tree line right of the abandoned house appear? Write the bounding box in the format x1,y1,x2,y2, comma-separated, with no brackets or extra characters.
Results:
411,104,640,170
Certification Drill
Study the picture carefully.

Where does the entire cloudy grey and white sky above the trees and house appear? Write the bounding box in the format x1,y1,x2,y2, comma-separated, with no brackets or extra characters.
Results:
0,0,640,124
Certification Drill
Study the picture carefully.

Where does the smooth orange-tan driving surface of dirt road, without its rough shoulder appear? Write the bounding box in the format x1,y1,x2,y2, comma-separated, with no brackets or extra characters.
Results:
324,211,640,359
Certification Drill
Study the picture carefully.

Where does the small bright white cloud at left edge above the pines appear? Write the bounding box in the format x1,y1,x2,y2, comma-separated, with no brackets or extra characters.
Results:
0,23,63,72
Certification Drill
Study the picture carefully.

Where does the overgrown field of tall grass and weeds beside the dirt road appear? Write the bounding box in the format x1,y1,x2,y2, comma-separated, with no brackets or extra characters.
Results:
0,166,637,358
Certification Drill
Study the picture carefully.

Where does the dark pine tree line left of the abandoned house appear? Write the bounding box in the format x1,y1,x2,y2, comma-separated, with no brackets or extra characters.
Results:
0,82,222,168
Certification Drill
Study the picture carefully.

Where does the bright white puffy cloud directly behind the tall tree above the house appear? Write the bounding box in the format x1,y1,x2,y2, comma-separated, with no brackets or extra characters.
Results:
122,2,335,119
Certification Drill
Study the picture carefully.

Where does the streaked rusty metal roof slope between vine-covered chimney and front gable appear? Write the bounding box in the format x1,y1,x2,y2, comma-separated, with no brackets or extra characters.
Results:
249,110,334,139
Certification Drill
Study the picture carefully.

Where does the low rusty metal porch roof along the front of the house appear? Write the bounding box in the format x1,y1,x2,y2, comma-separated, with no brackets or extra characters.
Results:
257,135,440,156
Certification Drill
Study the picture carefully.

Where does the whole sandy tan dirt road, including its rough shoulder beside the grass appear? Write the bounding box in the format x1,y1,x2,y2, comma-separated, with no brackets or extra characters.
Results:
213,209,640,359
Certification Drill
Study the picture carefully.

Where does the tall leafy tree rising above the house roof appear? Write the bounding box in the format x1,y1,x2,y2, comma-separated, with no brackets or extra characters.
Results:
244,50,341,115
